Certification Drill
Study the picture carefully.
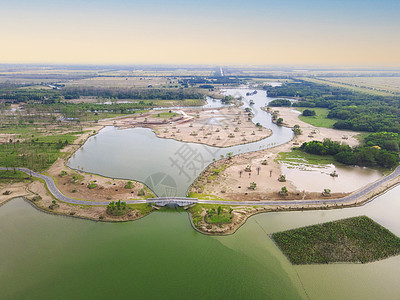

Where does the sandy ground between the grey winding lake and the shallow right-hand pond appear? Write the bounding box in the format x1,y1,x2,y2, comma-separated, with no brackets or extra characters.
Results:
190,108,359,200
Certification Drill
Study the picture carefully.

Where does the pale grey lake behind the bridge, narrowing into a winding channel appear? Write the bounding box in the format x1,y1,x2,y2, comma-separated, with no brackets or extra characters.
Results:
67,89,293,197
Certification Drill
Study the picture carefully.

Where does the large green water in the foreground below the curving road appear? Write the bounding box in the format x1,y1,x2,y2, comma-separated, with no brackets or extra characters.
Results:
0,187,400,299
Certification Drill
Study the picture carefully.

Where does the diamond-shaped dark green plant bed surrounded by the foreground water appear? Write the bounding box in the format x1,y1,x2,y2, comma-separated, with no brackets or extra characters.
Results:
272,216,400,265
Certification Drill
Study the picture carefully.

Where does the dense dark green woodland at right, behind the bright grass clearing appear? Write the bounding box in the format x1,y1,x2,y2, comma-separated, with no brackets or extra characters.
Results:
265,79,400,133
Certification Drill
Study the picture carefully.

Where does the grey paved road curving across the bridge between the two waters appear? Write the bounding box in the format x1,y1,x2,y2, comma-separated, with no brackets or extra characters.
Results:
0,166,400,206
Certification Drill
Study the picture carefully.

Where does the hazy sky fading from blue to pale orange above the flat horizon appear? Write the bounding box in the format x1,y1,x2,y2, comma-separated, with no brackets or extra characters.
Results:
0,0,400,67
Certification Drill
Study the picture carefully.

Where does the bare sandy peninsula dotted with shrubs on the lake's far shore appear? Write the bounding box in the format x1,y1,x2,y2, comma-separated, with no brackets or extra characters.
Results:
100,107,271,147
